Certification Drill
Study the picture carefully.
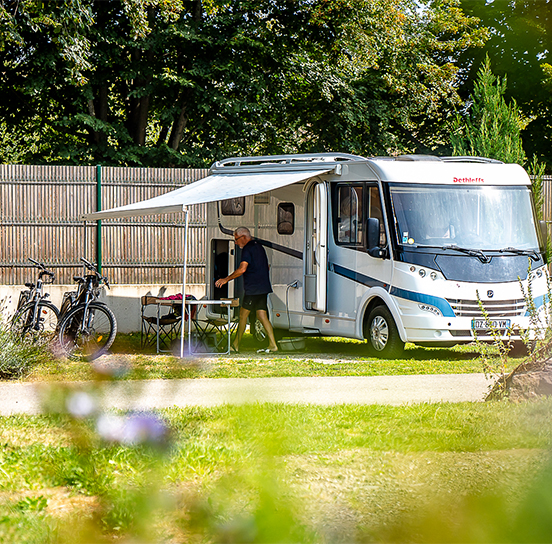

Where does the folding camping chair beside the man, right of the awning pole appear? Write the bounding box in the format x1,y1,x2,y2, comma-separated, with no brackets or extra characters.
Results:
193,299,239,354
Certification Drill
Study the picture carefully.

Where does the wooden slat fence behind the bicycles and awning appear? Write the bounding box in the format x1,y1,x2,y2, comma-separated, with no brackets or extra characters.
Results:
0,165,209,285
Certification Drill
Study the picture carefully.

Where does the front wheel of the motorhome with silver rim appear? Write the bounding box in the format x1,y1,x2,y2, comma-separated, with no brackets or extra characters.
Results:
364,306,404,359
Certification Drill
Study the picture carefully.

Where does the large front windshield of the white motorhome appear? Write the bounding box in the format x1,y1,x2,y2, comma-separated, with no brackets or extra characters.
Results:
390,184,539,251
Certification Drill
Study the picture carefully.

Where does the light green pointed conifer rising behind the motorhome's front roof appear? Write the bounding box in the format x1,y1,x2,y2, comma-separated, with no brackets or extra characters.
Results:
451,57,528,165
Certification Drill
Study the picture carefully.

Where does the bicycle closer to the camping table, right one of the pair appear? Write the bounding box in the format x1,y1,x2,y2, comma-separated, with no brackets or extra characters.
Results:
58,257,117,360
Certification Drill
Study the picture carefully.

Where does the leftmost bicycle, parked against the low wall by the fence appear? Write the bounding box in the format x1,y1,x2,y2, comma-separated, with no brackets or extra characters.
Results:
10,259,60,341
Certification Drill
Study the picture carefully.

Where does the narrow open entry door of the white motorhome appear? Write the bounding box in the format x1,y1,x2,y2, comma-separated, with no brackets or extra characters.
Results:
304,183,328,312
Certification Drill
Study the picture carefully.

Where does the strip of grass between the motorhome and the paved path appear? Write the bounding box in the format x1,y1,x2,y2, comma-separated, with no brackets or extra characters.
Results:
19,334,520,381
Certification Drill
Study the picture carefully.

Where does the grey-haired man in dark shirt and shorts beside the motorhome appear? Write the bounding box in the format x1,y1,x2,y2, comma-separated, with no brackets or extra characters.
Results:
215,227,278,353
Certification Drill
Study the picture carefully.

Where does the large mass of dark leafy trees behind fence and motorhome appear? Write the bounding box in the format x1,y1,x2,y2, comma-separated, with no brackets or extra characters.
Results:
0,0,486,166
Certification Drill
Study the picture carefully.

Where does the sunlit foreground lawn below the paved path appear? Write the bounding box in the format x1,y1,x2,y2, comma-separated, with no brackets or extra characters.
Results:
0,399,552,544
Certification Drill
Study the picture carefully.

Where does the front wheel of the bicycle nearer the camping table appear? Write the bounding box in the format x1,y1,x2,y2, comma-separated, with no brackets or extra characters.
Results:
59,302,117,360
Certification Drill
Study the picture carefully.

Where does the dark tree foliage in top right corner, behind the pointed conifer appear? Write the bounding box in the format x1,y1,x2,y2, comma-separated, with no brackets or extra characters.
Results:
459,0,552,170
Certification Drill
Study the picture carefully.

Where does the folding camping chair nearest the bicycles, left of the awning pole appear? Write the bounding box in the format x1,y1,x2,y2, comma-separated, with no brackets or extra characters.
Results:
140,295,182,353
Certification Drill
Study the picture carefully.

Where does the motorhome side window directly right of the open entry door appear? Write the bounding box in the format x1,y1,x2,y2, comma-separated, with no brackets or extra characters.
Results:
336,185,364,246
